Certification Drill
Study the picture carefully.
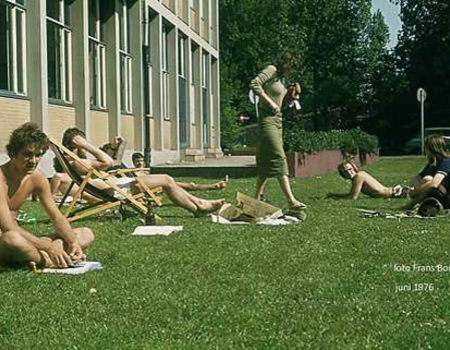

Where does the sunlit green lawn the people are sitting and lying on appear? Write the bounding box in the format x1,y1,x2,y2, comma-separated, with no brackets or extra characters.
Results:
0,158,450,350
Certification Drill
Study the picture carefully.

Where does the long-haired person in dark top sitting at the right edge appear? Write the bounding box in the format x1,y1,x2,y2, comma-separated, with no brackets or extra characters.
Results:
402,135,450,209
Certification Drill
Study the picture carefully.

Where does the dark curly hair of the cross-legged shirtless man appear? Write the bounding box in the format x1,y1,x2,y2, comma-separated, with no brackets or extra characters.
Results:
6,122,50,158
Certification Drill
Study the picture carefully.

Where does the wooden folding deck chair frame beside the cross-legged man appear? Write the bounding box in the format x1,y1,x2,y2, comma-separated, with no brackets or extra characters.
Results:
50,139,162,222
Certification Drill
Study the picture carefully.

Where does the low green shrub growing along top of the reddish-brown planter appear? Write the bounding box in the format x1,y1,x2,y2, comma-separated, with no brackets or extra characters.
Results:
284,128,378,155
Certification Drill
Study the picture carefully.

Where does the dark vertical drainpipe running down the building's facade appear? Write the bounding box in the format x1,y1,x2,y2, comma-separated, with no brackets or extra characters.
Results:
142,1,152,167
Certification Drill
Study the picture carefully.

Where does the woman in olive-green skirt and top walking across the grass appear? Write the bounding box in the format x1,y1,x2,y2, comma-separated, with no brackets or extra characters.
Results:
250,53,306,210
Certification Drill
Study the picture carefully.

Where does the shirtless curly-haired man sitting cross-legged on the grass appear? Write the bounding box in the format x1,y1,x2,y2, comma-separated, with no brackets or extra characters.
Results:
0,123,94,268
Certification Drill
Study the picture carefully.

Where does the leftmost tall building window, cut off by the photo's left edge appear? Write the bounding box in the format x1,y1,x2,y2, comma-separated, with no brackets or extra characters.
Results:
0,1,26,95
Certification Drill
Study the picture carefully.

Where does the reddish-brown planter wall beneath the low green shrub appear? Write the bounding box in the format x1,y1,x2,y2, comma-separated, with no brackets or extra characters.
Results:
287,150,380,177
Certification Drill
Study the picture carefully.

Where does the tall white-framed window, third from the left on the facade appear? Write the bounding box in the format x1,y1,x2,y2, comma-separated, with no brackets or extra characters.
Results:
89,0,106,108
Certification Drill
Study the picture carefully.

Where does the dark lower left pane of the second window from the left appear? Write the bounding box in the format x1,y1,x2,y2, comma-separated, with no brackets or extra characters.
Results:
47,22,61,99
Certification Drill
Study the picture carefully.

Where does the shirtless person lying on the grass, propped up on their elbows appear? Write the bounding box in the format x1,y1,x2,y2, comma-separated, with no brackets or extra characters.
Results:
327,161,409,200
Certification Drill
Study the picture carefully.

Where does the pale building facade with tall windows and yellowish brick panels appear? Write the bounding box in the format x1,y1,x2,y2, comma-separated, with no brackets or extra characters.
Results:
0,0,222,171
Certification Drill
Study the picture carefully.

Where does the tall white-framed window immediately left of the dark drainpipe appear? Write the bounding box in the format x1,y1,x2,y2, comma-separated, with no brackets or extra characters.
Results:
119,0,132,113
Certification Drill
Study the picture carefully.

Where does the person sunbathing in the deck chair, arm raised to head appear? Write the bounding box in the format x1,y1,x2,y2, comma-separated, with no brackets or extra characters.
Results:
63,128,225,216
